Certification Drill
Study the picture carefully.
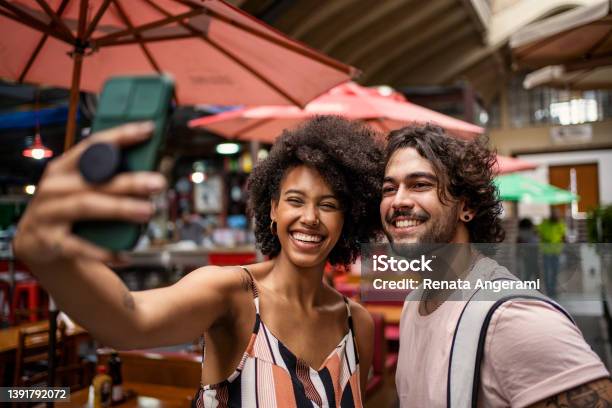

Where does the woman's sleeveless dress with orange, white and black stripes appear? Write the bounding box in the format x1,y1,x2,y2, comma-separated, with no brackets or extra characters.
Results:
192,267,362,408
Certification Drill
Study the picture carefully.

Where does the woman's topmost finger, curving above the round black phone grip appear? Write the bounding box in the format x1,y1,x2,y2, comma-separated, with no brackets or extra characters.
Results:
49,122,155,172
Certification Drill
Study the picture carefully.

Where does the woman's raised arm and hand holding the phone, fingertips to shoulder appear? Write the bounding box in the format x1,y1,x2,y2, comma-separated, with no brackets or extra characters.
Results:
13,124,243,348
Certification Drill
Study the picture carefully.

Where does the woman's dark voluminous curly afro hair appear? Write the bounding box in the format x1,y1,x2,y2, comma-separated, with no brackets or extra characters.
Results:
248,116,384,265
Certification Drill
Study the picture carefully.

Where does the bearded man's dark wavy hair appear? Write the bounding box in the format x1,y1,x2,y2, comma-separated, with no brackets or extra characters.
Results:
385,124,505,243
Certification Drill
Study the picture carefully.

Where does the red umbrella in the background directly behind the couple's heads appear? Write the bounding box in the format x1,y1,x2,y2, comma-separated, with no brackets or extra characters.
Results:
189,82,484,143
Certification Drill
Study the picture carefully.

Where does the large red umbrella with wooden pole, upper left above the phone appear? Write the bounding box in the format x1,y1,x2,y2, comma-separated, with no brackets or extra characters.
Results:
0,0,357,147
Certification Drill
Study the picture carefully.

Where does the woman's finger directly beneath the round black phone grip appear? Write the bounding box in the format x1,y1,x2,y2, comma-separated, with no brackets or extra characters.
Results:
38,172,166,197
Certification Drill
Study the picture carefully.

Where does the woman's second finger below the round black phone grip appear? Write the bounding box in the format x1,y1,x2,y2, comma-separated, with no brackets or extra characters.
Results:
36,191,155,223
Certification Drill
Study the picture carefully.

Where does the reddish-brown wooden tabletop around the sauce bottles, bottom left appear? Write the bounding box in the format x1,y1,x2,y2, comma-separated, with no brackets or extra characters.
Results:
71,382,197,408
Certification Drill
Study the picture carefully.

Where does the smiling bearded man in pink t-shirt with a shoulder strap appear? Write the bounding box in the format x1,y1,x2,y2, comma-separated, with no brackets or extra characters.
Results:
380,125,612,408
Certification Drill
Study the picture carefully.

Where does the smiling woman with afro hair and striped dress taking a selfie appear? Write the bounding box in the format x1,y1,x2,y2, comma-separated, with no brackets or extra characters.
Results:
14,116,383,407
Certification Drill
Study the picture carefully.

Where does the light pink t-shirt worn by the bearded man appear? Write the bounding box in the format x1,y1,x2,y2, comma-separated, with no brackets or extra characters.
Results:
396,260,609,408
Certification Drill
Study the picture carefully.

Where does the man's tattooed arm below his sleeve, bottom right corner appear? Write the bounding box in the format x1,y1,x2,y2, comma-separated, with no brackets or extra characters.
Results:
543,378,612,408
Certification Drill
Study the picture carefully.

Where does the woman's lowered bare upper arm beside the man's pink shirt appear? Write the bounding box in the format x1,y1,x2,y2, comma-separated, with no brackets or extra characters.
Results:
350,301,374,398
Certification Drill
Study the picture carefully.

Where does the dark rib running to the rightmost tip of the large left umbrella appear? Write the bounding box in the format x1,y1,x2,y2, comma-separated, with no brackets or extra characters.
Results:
173,0,359,77
